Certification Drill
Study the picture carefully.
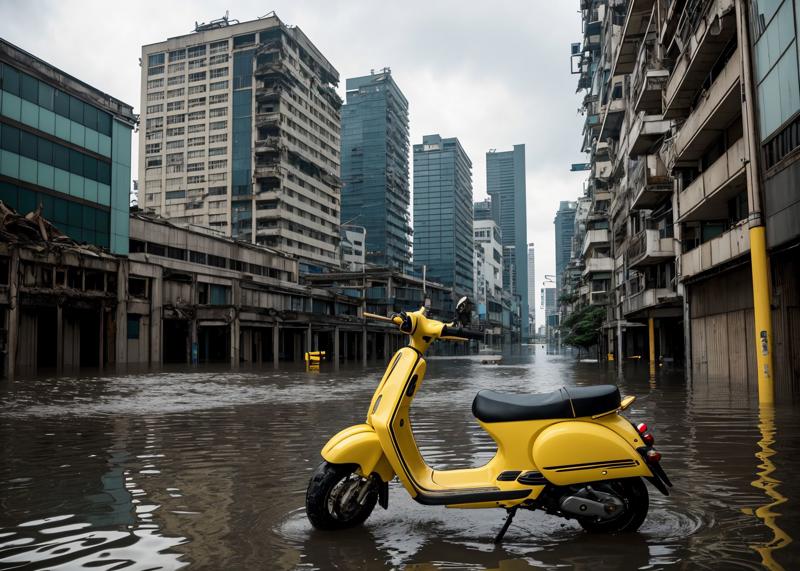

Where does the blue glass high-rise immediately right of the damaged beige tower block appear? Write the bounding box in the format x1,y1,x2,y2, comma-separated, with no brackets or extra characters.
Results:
342,68,411,272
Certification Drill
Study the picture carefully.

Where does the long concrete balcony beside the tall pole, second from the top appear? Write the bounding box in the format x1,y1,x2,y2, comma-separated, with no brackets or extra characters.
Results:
675,49,742,161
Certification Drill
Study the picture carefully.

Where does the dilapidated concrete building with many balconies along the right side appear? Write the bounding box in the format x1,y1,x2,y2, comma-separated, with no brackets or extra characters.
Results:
575,0,800,396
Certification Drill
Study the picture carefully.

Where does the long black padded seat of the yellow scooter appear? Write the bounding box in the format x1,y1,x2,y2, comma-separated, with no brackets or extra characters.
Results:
472,385,620,422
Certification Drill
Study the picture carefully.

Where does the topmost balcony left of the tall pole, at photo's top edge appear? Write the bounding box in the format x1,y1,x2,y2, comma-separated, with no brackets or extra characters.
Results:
664,0,736,118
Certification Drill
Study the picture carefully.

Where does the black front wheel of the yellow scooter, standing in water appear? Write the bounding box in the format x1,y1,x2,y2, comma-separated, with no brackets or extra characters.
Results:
306,462,378,530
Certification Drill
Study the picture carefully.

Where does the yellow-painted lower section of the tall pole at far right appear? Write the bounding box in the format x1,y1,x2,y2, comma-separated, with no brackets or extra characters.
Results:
750,226,775,404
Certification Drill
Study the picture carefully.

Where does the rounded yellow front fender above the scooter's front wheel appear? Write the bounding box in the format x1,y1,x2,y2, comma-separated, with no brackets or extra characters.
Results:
322,424,394,482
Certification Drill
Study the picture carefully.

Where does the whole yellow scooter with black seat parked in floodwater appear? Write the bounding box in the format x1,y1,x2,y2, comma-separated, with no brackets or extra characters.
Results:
306,298,672,542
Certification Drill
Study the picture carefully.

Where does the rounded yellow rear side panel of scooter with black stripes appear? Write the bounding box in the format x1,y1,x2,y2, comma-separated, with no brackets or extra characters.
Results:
533,421,653,486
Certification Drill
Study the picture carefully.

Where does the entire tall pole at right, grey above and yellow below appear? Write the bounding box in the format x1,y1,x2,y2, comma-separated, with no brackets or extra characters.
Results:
735,0,775,404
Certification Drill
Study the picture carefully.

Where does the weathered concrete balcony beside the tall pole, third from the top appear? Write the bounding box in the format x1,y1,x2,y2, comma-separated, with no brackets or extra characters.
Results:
678,138,747,222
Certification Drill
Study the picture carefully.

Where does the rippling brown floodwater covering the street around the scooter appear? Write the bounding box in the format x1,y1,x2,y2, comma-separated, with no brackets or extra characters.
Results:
0,347,800,571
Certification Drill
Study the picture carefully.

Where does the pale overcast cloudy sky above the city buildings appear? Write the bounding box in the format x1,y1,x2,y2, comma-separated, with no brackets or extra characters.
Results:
0,0,585,324
